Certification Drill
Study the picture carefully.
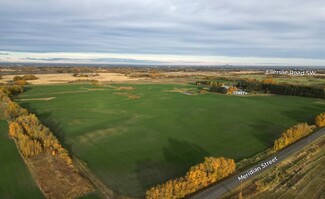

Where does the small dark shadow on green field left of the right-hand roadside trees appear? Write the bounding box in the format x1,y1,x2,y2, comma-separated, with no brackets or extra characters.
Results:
251,120,285,147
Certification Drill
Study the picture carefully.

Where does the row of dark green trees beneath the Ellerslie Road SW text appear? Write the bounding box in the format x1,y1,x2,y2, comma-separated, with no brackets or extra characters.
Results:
237,79,325,98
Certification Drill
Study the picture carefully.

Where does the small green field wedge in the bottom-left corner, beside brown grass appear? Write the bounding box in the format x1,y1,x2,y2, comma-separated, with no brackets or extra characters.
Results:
0,120,44,199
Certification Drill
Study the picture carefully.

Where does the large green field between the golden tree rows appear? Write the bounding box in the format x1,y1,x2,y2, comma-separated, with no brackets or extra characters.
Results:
16,84,325,197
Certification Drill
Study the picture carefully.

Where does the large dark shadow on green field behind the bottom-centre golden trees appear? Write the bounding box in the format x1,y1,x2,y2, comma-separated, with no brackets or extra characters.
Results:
136,138,210,196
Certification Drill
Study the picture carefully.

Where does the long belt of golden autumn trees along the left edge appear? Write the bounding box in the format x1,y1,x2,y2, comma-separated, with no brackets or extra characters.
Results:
0,85,72,166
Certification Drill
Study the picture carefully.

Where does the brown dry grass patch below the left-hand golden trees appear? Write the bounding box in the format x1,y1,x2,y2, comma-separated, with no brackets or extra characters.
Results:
25,154,94,199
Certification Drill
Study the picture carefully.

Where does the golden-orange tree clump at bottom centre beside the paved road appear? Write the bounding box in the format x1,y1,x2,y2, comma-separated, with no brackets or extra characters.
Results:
146,157,236,199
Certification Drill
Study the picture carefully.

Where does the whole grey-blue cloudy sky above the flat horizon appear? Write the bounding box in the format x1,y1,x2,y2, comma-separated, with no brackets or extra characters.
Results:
0,0,325,66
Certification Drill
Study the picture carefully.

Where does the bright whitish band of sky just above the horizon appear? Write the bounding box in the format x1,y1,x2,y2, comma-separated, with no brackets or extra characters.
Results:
0,51,325,67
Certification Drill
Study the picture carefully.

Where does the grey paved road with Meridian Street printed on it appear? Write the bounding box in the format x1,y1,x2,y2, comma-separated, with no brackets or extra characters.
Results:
188,128,325,199
